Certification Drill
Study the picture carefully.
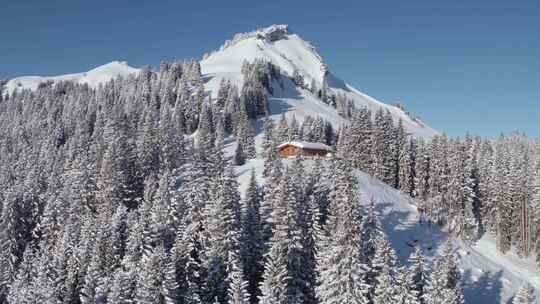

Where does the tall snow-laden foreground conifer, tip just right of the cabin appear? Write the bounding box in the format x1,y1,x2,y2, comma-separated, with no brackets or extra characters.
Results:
316,160,369,304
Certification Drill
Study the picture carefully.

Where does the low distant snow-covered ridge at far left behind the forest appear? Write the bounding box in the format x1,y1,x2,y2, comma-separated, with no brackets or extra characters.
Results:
6,61,139,93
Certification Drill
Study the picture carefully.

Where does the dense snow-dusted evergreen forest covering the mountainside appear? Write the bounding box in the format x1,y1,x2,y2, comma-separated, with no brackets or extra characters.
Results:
0,60,540,304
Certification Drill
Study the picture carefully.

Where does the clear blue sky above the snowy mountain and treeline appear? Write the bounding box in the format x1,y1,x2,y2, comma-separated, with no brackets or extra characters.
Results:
0,0,540,137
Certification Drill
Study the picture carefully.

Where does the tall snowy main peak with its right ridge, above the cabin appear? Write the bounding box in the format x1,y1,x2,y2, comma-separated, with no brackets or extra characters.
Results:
201,25,437,138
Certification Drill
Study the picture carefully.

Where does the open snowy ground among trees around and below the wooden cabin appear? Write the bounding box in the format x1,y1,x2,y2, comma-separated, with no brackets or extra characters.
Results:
231,150,540,304
